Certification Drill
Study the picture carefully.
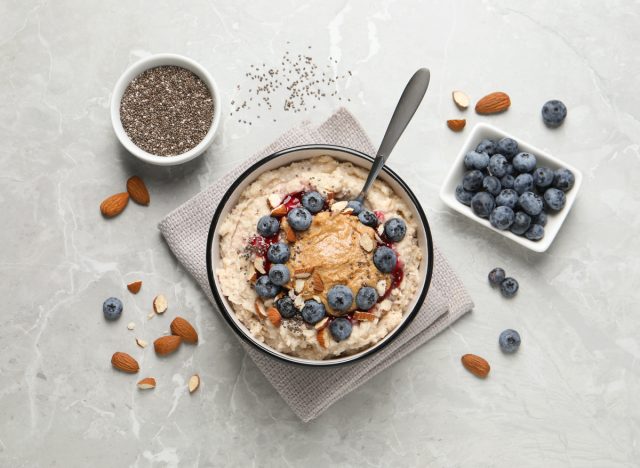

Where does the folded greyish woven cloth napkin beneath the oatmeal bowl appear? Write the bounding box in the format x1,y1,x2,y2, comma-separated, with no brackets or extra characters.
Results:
159,109,473,422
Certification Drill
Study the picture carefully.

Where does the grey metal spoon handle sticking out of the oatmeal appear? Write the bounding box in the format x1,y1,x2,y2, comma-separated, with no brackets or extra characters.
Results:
356,68,431,202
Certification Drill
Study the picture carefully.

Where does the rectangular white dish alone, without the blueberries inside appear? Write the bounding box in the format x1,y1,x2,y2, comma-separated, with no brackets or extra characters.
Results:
440,123,582,252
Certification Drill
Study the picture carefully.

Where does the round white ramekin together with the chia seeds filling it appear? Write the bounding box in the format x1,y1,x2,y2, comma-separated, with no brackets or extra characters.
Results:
111,54,221,166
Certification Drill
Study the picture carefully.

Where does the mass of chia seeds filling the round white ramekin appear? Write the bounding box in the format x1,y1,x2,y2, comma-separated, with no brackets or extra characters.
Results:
120,66,213,156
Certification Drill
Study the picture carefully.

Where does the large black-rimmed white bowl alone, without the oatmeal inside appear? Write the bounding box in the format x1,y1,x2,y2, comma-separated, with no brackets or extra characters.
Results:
206,145,433,367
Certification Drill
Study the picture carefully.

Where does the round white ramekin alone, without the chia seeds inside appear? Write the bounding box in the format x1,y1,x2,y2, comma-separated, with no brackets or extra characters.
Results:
111,54,221,166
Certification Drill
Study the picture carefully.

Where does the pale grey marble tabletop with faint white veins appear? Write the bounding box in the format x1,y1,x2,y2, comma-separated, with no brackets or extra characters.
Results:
0,0,640,467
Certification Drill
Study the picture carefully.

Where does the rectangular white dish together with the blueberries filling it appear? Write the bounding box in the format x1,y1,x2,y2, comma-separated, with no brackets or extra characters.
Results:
440,123,582,252
